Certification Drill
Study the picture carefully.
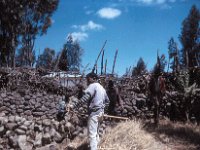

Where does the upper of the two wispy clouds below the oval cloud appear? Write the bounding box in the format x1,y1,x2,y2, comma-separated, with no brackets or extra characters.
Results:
72,21,104,32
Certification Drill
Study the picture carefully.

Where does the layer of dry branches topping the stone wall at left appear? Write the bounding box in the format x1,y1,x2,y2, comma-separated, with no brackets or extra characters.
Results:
0,68,71,94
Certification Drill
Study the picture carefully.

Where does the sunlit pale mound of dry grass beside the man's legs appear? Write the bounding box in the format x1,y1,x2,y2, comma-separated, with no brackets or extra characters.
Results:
100,121,167,150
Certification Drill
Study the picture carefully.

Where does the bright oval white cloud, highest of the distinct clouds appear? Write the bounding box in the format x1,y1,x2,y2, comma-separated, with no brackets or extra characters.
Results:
97,7,121,19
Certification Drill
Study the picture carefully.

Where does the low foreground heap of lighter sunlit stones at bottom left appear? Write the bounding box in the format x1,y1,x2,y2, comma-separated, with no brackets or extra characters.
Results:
0,113,85,150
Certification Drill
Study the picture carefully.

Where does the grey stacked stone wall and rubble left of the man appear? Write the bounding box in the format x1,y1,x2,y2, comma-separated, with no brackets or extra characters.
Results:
0,91,94,150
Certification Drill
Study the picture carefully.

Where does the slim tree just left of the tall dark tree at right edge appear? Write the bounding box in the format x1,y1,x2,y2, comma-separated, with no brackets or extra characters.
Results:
168,38,179,72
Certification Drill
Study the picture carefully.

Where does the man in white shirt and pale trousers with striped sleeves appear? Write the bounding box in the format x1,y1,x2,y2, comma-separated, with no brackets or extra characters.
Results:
71,72,109,150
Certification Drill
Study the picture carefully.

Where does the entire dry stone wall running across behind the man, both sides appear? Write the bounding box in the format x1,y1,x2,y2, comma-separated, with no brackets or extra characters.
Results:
0,68,200,150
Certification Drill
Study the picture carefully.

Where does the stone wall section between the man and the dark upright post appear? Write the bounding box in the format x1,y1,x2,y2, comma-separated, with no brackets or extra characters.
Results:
113,77,148,118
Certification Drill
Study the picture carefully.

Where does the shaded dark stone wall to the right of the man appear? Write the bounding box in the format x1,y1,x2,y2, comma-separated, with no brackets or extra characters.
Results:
116,75,200,122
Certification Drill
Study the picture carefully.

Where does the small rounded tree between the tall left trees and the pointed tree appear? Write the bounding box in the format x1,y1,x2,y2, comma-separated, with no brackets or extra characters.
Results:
37,48,56,69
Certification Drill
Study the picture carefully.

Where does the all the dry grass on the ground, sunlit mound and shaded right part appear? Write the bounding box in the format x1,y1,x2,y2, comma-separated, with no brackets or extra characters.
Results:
65,120,200,150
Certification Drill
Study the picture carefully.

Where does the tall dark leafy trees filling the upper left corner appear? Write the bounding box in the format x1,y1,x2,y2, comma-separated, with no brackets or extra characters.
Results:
0,0,59,66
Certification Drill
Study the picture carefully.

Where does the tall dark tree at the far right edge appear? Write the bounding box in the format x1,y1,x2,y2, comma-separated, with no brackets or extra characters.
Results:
180,5,200,69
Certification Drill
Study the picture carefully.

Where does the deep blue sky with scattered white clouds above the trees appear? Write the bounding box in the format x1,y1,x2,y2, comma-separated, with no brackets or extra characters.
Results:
35,0,200,75
